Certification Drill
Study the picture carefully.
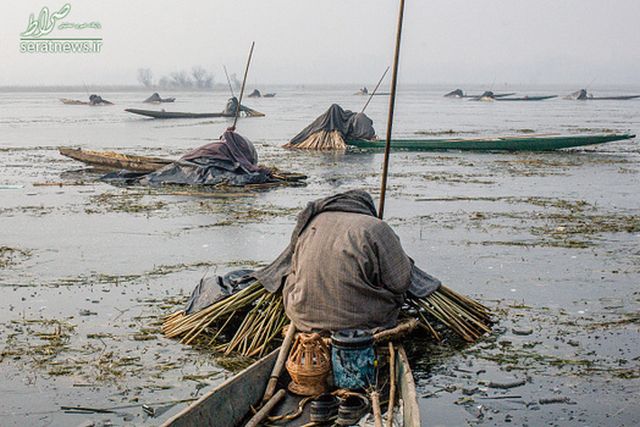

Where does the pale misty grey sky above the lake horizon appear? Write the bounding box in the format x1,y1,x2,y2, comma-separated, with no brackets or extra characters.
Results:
0,0,640,86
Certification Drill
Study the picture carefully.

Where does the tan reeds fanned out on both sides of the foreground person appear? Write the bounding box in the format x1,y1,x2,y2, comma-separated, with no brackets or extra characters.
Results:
162,282,491,357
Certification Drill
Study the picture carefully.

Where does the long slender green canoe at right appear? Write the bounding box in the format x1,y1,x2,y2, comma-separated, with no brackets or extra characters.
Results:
347,134,635,151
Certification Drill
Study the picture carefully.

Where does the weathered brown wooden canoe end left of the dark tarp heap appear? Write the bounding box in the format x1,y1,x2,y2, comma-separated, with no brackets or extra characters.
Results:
58,147,172,172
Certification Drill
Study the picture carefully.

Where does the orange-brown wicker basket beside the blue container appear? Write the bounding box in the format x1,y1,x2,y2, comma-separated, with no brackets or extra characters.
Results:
286,333,331,396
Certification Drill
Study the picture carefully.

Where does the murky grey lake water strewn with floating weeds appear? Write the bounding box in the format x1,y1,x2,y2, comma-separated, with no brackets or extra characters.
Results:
0,87,640,426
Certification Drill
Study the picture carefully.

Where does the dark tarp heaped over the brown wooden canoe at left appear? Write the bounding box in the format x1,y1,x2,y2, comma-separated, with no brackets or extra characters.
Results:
102,130,271,186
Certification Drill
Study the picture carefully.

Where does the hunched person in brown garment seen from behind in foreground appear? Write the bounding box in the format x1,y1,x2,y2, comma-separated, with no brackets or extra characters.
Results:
251,190,440,331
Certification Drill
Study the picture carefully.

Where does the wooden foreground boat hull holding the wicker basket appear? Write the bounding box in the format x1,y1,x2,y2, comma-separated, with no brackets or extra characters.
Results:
162,346,420,427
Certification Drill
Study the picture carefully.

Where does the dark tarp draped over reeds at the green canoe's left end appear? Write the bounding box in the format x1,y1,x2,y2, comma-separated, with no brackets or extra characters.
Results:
288,104,376,146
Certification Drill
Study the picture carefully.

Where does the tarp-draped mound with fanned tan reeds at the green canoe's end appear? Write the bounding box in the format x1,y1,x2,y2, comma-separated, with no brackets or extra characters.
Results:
284,104,376,150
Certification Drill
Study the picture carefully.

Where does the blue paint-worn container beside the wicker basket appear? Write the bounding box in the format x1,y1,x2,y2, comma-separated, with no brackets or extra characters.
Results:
331,329,376,390
